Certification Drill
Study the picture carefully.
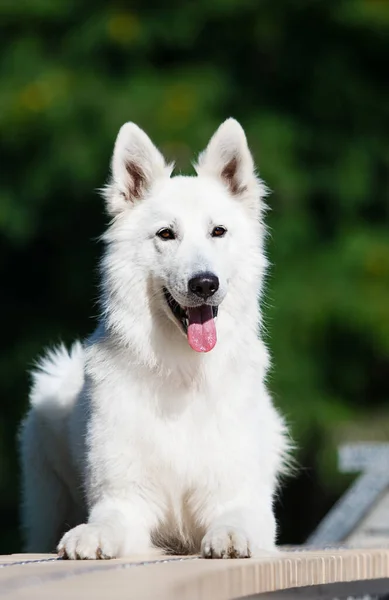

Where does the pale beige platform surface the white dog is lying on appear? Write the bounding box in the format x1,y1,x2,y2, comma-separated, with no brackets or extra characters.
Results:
0,547,389,600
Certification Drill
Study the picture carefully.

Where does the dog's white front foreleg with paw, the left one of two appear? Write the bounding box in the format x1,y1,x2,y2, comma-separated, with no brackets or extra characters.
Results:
57,496,157,559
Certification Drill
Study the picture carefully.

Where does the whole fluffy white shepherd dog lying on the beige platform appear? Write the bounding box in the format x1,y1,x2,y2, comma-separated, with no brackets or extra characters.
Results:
20,119,288,559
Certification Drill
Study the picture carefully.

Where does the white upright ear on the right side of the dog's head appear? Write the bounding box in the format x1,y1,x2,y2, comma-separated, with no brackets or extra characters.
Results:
195,119,266,207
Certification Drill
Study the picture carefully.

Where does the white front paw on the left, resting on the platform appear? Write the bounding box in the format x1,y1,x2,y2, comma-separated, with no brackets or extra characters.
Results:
57,524,118,560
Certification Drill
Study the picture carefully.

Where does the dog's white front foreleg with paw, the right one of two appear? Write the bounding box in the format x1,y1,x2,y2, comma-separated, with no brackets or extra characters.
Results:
201,490,276,558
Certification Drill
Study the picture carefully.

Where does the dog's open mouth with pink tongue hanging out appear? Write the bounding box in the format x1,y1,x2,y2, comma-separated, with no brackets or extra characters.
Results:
163,288,218,352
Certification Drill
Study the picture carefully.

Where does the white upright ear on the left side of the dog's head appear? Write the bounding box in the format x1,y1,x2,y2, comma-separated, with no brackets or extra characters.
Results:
104,123,172,216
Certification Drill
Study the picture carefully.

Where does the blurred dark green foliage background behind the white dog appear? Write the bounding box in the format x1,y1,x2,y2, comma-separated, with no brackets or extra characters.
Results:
0,0,389,552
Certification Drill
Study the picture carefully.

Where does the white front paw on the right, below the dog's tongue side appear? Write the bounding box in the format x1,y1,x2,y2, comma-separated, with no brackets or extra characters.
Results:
201,527,251,558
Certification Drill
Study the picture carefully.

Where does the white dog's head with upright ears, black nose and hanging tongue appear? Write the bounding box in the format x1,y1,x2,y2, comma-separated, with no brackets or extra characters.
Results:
101,119,264,352
